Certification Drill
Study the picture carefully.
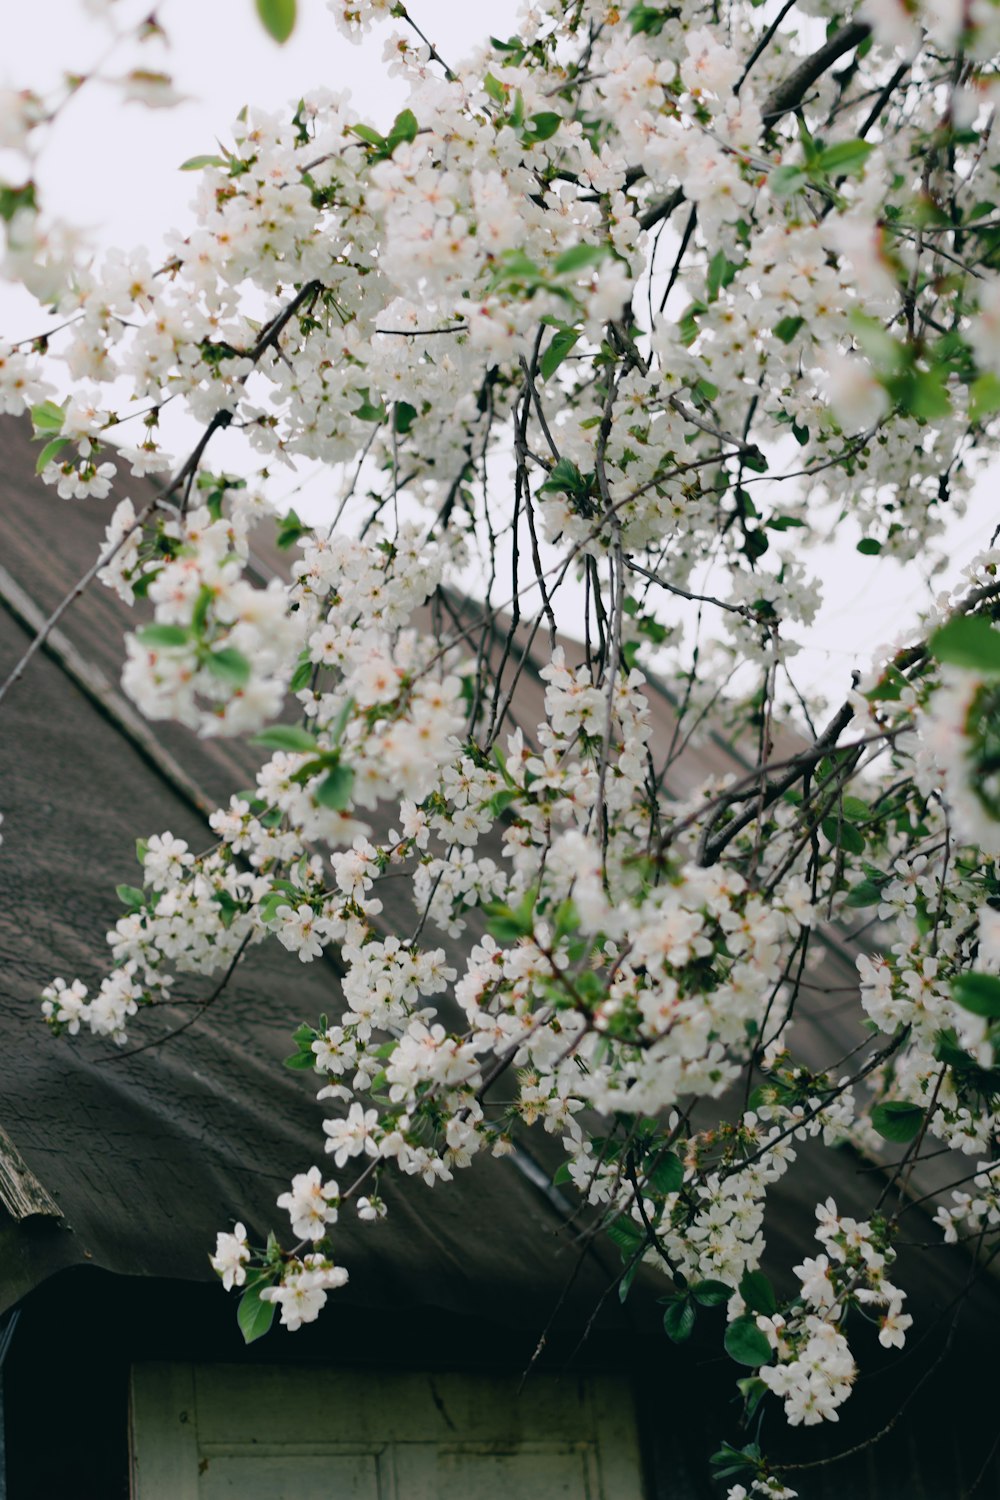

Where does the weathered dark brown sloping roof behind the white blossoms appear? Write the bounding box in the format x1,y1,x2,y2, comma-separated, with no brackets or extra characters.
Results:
0,417,995,1350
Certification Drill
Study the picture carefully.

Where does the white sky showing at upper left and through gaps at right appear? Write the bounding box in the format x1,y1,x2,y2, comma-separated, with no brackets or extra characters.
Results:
0,0,1000,698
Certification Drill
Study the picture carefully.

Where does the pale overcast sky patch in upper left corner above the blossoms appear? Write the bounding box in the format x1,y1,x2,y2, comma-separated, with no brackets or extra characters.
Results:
0,0,519,335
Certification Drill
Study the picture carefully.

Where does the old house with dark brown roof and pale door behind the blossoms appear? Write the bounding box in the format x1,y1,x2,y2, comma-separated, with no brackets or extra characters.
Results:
0,419,1000,1500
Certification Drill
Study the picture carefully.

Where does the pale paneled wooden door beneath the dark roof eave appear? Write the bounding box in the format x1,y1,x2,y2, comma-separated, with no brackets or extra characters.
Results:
132,1365,643,1500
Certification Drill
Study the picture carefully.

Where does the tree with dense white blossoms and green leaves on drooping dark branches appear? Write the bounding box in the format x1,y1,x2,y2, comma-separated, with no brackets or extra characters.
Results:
0,0,1000,1500
